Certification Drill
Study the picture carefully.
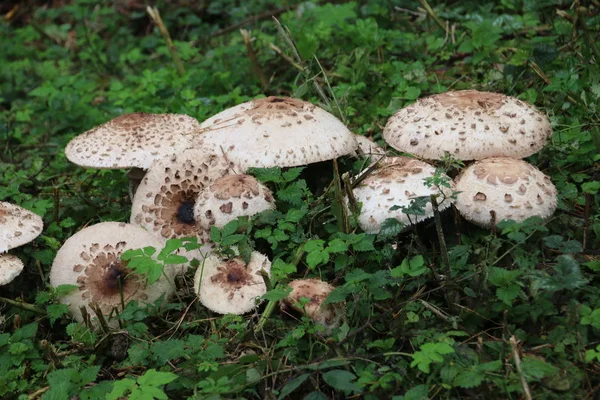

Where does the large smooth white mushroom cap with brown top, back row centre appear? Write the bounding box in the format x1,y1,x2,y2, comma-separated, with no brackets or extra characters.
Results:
194,97,356,168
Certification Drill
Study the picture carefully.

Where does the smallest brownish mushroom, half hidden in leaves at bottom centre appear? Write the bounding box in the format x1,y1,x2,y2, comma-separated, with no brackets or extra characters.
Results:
281,279,344,329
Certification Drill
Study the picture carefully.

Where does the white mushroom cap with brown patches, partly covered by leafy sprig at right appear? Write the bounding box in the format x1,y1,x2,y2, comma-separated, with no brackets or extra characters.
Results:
353,157,452,233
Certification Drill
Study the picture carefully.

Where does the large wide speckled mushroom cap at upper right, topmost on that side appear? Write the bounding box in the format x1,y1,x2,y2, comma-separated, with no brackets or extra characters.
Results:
383,90,552,160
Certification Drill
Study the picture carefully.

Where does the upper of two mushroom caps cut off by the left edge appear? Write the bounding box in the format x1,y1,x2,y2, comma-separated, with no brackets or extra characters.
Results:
0,201,44,253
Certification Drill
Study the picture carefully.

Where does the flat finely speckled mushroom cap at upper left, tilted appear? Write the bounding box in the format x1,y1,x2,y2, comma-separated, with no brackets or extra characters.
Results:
65,113,200,169
